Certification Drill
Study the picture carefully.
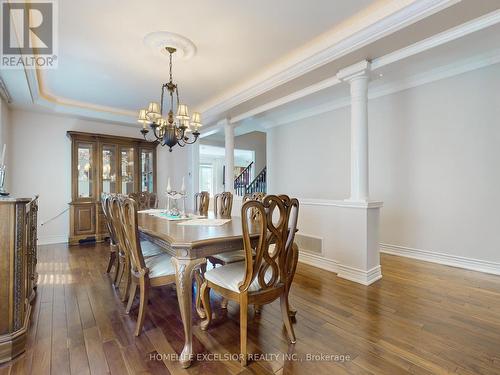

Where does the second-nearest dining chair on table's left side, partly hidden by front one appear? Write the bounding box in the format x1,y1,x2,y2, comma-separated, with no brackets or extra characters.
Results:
109,194,163,302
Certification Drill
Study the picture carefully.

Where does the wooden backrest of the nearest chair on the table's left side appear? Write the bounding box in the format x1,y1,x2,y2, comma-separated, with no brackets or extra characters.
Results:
121,198,147,273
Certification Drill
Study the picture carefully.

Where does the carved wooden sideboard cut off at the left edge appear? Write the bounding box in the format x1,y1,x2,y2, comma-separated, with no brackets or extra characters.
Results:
0,198,38,363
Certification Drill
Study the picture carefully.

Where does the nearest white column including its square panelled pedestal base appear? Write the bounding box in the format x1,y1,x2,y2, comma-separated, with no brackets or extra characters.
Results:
335,60,383,285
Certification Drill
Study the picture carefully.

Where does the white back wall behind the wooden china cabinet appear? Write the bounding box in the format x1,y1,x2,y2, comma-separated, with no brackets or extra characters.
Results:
8,109,189,243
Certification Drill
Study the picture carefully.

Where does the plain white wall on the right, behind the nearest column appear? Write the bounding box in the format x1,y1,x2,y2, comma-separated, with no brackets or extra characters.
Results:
268,65,500,262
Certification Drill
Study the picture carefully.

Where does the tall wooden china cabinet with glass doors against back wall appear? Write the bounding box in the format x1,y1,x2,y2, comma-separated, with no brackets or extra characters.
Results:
67,131,158,245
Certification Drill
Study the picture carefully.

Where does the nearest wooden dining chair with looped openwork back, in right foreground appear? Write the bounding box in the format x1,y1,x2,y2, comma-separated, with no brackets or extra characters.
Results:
201,195,299,366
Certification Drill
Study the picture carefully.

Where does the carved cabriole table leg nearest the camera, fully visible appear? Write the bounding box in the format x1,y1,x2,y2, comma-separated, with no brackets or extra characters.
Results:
172,257,206,368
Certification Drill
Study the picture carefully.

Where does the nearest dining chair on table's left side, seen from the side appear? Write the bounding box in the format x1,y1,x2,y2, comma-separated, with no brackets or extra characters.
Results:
120,198,180,336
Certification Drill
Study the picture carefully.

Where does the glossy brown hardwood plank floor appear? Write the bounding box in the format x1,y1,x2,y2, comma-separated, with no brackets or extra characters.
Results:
0,245,500,375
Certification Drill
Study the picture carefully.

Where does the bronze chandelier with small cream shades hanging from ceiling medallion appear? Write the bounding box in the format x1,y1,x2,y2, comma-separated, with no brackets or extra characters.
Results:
137,47,201,152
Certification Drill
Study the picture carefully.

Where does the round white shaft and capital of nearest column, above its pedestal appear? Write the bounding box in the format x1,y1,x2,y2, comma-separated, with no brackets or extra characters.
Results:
337,60,370,202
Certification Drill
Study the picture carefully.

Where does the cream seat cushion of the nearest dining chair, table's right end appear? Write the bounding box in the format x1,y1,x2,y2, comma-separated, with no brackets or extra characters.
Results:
205,262,271,293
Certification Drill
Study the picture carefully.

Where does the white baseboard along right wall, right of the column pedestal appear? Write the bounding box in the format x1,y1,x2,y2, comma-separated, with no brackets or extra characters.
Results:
380,243,500,275
